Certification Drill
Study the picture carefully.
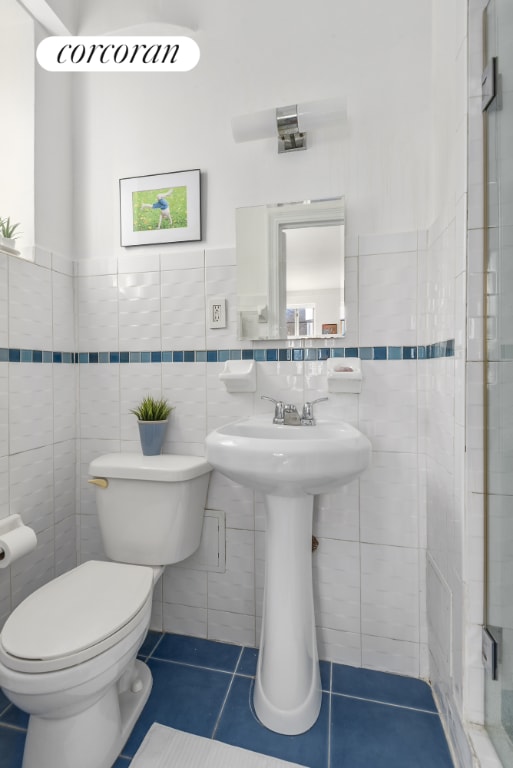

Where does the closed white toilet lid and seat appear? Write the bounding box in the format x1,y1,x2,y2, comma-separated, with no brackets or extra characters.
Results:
0,560,154,673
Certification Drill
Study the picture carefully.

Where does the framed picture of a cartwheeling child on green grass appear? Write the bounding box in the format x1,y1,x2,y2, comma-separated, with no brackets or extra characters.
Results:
119,168,201,246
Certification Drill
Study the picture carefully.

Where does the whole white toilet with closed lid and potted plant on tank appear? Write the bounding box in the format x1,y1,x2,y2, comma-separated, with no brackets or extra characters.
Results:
0,453,211,768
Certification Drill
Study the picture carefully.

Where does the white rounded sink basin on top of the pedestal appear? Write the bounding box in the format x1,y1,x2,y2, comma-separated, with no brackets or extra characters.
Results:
206,414,371,496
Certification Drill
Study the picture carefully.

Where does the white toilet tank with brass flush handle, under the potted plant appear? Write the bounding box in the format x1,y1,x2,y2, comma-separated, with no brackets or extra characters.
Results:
89,453,212,565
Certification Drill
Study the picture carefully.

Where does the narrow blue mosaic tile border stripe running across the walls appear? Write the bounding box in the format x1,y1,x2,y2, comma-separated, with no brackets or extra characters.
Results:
0,339,454,364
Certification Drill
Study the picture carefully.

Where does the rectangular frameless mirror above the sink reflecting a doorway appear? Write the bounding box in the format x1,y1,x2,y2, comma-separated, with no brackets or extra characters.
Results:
235,197,345,340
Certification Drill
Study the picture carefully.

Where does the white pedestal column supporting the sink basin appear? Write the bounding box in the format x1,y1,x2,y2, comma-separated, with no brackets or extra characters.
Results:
254,495,321,734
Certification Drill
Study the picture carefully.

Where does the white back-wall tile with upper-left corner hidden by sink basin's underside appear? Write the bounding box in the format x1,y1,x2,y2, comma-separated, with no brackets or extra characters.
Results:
360,451,419,547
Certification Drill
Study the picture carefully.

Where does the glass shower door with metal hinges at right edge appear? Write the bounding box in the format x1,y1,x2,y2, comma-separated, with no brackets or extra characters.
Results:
485,0,513,766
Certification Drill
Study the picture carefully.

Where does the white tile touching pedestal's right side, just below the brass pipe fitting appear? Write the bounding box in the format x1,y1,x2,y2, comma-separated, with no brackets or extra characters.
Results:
312,539,360,633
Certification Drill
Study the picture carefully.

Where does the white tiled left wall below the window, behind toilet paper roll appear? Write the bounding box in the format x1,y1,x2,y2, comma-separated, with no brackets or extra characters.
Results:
0,255,77,627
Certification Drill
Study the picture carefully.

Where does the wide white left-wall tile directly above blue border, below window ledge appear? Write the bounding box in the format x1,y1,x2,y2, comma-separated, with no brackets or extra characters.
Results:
9,259,52,349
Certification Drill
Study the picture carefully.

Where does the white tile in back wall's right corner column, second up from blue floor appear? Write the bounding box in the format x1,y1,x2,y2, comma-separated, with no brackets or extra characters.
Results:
361,544,419,644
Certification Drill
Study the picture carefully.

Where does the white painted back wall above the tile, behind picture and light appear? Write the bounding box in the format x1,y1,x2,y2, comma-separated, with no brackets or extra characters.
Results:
74,0,431,258
